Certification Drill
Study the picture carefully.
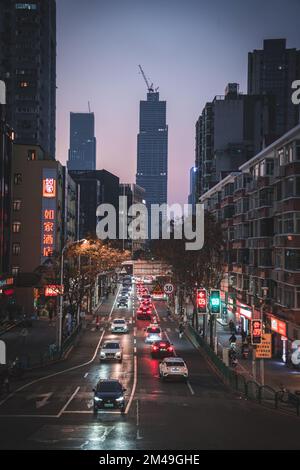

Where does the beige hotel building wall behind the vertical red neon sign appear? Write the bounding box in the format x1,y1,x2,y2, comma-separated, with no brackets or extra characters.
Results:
11,145,64,273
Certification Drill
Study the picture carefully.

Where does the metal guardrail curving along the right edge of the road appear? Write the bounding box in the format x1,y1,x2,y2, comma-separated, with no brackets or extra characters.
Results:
187,326,300,416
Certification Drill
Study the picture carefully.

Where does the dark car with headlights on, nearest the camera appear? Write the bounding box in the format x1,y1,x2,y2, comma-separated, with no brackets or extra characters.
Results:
93,379,126,414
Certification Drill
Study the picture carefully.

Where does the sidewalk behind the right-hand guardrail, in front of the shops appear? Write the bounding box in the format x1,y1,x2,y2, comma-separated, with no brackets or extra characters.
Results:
217,322,300,392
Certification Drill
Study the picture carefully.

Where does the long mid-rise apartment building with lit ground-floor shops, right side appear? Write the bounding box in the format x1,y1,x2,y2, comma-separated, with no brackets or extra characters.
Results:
201,125,300,361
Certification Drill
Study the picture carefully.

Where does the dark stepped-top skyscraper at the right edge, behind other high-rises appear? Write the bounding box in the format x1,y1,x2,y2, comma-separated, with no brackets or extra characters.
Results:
248,39,300,139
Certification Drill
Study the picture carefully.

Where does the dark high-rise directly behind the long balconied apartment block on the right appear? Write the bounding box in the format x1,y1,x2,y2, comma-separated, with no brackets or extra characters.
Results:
195,83,275,201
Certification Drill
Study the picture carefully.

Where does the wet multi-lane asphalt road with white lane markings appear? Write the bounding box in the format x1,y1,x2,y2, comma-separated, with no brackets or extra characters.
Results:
0,284,300,450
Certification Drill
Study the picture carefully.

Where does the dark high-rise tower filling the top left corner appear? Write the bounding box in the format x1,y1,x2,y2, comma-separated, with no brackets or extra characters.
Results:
0,0,56,158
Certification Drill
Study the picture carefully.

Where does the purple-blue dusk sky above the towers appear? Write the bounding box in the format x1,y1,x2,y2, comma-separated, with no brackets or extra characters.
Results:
56,0,300,203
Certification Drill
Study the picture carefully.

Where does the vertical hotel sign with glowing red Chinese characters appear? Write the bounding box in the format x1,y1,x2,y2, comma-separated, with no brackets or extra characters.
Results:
41,168,57,264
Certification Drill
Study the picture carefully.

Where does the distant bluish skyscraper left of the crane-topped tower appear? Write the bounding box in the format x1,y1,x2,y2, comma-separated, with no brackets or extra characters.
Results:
68,113,96,171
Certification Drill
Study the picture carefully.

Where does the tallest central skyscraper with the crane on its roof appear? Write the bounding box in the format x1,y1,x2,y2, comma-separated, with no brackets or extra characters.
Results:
136,88,168,215
